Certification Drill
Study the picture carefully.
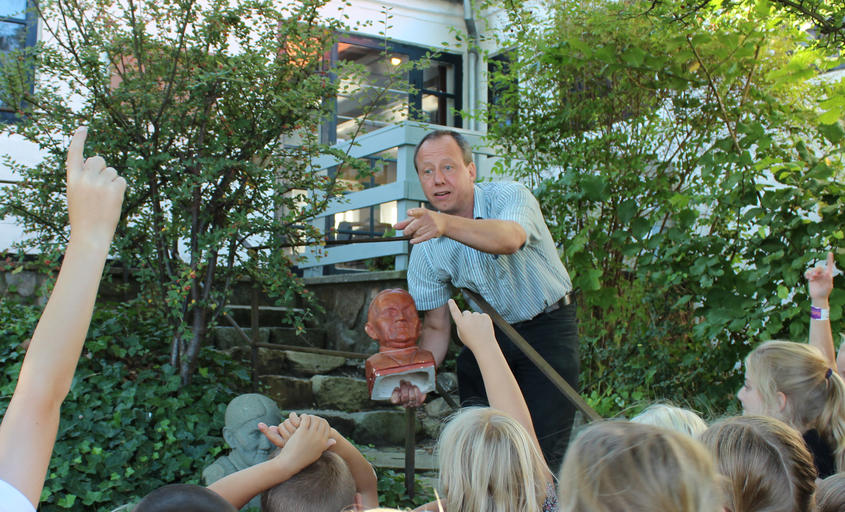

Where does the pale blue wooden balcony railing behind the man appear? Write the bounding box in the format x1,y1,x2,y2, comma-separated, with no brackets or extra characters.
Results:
299,121,494,276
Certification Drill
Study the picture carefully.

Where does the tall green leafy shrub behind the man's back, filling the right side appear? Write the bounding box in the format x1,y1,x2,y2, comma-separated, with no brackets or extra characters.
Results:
478,0,845,414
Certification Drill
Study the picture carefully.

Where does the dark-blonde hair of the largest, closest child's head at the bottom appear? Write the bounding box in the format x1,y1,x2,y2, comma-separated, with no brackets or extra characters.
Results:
558,421,723,512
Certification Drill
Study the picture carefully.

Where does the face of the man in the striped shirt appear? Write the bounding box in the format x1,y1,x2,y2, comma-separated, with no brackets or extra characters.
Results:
415,135,475,218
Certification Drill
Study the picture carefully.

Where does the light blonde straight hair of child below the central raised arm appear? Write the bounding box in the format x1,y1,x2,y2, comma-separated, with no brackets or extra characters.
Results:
437,407,548,512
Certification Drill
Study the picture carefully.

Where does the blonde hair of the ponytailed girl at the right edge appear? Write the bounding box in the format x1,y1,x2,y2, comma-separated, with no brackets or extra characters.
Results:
745,341,845,471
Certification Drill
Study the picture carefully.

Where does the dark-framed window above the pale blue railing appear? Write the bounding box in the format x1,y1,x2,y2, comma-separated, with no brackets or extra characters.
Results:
325,36,461,144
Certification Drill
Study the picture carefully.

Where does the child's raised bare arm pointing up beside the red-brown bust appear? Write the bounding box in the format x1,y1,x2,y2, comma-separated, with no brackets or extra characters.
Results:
449,299,542,464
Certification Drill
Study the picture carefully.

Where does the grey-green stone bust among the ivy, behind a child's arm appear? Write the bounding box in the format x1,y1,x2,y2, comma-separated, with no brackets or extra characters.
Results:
202,393,282,507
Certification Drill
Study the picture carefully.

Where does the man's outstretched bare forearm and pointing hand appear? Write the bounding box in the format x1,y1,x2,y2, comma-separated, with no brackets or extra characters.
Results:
394,208,528,254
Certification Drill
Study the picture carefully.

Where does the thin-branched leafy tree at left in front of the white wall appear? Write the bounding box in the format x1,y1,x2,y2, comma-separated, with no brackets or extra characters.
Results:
0,0,370,384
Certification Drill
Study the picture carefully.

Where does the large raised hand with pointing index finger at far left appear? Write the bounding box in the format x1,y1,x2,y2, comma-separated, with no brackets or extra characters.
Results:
65,126,126,249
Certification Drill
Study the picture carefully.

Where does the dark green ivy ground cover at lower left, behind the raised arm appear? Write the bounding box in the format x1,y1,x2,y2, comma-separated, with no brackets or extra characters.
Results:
0,301,249,512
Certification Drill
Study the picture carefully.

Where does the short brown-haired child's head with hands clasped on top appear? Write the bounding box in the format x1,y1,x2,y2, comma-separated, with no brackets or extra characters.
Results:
261,451,355,512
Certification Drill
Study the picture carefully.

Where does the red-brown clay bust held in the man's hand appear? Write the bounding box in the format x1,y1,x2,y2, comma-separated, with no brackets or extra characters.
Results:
364,288,434,400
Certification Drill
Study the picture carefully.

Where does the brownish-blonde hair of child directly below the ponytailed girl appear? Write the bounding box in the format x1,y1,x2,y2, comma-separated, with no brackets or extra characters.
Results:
701,416,816,512
